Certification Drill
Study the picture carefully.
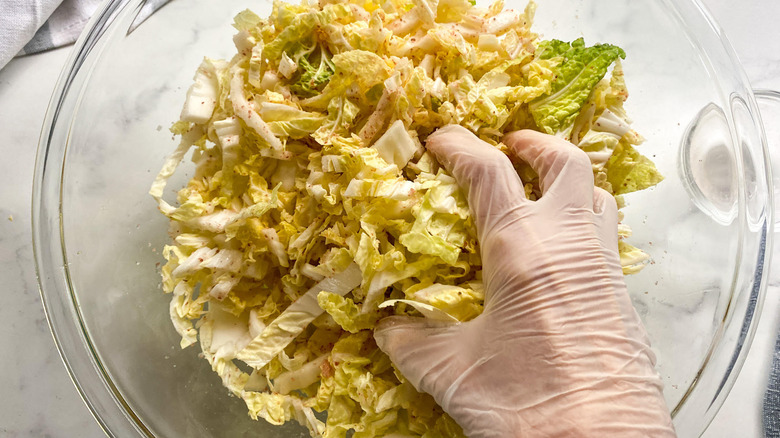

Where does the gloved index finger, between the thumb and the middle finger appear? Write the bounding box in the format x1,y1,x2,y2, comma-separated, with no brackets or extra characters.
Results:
426,125,526,235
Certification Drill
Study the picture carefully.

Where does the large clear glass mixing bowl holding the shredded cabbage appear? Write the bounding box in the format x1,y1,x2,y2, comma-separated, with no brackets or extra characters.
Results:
33,0,773,437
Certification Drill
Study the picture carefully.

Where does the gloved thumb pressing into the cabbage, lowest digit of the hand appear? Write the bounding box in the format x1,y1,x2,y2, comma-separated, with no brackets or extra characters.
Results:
374,316,458,399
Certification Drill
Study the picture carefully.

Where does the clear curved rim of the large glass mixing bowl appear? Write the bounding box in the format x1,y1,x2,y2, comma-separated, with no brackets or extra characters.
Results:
32,0,773,437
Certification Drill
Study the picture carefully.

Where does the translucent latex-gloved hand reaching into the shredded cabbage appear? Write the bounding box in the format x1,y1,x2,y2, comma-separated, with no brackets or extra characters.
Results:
375,126,675,437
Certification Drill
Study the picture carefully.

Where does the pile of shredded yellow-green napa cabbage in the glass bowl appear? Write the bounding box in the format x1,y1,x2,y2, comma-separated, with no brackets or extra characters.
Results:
150,0,661,438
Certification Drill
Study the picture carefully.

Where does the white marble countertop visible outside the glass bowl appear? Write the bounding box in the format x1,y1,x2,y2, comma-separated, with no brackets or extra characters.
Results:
0,0,780,438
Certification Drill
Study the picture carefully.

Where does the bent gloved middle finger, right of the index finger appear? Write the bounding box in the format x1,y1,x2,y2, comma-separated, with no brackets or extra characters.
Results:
503,129,593,208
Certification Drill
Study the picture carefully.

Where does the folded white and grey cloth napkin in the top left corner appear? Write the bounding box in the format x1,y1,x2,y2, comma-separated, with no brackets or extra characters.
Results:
0,0,168,69
